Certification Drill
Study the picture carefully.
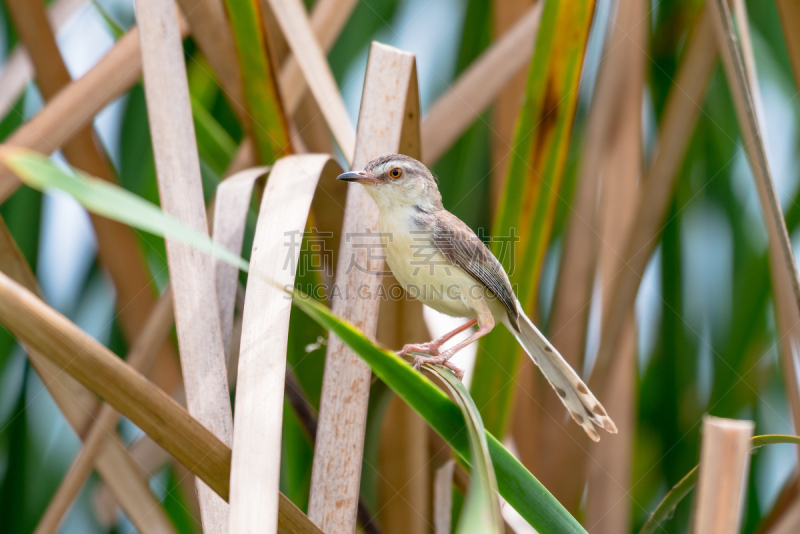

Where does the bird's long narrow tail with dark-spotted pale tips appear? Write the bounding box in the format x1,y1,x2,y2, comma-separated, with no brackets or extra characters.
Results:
506,311,617,441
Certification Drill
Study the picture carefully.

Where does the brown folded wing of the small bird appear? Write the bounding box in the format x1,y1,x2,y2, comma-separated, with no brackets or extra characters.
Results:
432,210,519,330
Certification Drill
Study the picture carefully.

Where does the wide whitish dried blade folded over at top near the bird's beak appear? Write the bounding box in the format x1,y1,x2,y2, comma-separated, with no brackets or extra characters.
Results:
230,155,341,532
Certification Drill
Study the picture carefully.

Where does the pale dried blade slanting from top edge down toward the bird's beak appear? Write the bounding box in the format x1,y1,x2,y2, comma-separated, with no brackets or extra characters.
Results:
261,0,355,162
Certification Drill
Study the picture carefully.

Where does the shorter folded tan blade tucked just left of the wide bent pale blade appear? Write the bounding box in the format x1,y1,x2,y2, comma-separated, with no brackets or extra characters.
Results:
212,167,270,361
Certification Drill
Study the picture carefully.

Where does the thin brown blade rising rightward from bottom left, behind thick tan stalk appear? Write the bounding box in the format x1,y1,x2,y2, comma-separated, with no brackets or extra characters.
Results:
35,289,174,534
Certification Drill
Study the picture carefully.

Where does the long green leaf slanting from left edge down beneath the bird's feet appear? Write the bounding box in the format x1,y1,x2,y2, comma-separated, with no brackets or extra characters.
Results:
0,147,585,534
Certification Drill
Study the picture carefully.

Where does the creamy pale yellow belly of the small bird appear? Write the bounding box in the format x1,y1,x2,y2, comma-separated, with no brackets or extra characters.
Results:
380,217,483,317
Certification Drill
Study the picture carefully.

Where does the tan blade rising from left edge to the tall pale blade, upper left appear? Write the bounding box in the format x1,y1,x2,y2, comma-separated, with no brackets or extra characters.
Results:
0,25,188,203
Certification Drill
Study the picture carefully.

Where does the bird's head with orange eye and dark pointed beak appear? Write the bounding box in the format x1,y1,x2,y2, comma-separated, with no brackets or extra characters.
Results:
339,154,442,211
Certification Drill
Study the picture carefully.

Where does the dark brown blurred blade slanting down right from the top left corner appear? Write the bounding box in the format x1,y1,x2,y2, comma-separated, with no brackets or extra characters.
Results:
6,0,183,418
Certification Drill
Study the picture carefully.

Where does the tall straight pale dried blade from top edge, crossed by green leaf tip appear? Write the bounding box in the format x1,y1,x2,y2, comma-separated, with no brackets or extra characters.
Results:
136,0,233,532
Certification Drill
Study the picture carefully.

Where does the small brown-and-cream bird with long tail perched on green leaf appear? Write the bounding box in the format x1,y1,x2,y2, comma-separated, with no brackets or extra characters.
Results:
339,154,617,441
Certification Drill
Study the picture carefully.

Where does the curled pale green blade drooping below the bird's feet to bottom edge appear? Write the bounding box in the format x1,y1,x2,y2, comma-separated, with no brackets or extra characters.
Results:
427,366,505,534
